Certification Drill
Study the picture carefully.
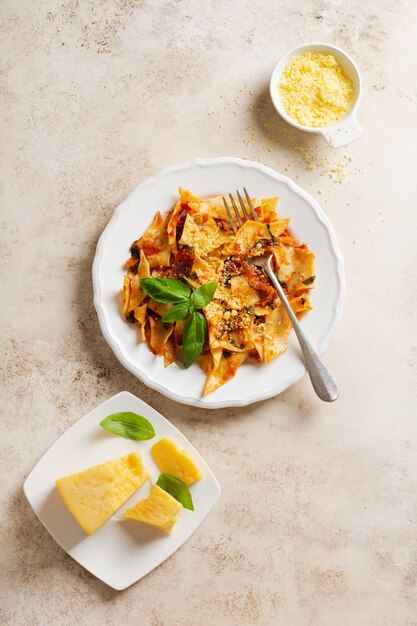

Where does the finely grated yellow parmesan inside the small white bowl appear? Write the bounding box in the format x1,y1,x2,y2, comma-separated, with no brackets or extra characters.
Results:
278,52,354,128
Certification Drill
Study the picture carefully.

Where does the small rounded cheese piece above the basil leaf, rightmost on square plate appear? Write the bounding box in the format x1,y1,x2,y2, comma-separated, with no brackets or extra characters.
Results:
152,439,201,485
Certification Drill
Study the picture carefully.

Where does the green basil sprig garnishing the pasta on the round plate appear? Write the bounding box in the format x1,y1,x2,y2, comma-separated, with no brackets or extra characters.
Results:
140,278,217,367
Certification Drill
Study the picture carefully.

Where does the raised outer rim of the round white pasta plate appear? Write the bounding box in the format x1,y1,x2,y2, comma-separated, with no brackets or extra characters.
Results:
92,157,346,409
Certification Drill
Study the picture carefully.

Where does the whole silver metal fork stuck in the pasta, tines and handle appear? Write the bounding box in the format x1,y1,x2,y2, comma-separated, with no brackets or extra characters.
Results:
223,187,339,402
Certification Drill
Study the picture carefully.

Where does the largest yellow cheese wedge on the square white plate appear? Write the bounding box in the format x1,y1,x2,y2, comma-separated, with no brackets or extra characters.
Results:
56,452,149,535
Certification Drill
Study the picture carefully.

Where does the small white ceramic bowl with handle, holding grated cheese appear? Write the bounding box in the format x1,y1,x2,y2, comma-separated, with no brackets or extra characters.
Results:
269,42,362,148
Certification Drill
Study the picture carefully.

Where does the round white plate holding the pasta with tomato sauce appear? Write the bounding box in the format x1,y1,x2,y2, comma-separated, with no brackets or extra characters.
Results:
93,157,345,409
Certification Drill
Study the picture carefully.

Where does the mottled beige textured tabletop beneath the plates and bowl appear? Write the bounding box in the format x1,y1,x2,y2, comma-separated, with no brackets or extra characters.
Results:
0,0,417,626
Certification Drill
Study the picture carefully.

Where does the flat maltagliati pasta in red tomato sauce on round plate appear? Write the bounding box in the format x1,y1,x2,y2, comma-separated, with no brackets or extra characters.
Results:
123,188,315,394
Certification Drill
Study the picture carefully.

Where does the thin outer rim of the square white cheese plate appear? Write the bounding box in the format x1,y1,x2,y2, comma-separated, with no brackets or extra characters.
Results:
22,390,222,591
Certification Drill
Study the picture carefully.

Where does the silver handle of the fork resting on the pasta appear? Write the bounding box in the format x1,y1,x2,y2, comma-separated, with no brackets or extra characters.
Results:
264,263,339,402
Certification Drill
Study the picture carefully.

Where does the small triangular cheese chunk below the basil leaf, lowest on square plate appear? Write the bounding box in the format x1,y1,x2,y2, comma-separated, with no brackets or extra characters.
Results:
123,485,182,533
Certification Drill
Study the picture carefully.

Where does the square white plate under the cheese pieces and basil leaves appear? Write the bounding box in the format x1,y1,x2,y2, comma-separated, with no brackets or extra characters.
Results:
23,391,220,590
